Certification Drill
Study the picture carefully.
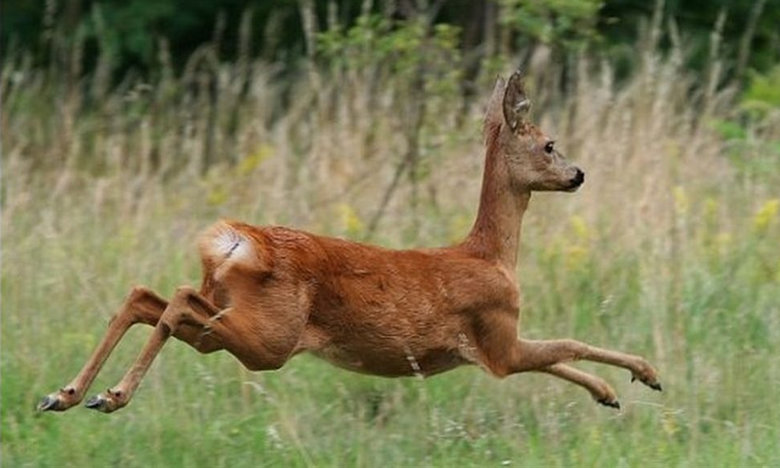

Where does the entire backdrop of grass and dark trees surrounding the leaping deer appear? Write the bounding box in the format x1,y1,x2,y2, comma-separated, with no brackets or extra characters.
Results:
0,0,780,467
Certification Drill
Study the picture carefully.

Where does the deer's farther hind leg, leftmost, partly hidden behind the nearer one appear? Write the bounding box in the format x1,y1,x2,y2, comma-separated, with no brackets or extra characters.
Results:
38,286,220,411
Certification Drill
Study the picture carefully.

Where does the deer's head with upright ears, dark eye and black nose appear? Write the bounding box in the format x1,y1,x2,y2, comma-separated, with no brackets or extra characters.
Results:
485,72,585,192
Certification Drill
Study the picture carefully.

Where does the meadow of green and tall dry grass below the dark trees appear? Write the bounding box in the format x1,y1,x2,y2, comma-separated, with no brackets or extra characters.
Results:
0,16,780,466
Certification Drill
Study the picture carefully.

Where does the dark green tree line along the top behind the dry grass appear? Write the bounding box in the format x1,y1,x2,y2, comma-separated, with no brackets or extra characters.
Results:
0,0,780,80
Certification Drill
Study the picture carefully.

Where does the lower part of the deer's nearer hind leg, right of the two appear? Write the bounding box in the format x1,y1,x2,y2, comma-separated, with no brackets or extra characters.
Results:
86,286,217,413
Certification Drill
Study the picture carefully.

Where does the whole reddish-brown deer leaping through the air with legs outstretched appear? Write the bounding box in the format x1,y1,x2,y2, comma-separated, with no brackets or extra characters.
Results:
38,72,662,413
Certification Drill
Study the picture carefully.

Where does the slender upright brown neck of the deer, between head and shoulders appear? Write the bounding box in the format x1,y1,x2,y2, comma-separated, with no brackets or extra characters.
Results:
464,139,531,272
